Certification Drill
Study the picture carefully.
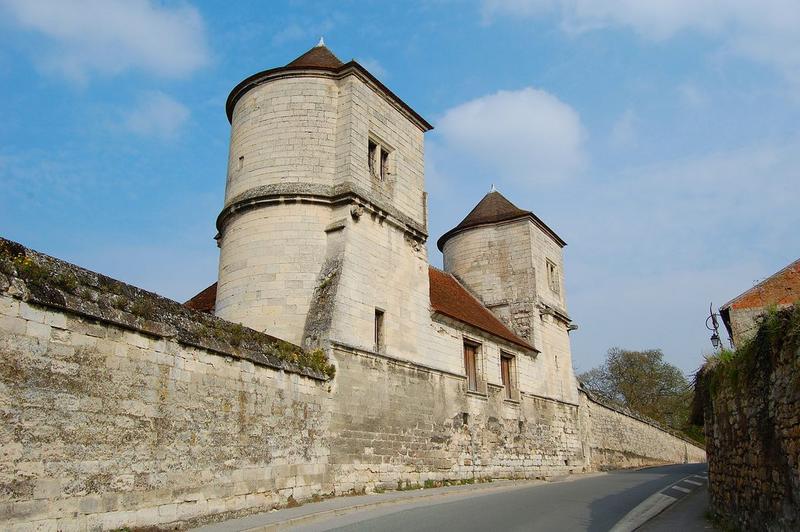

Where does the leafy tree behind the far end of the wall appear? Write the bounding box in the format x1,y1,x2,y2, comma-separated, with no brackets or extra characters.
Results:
578,347,692,430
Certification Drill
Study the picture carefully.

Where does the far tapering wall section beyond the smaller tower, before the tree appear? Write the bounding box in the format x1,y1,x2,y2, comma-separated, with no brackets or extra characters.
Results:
580,392,706,470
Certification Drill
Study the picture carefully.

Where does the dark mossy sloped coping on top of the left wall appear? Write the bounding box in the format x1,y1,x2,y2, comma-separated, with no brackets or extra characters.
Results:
0,238,334,380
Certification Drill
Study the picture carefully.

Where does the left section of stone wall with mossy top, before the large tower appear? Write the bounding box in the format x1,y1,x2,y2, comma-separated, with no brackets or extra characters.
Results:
0,240,332,530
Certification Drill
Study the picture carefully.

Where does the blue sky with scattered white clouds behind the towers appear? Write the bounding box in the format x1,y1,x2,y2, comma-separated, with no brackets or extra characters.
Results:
0,0,800,372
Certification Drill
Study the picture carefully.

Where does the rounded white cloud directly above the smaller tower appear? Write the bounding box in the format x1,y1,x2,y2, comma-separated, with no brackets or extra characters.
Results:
436,87,585,184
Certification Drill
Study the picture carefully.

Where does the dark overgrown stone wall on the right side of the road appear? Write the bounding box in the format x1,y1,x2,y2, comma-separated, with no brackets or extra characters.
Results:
699,305,800,530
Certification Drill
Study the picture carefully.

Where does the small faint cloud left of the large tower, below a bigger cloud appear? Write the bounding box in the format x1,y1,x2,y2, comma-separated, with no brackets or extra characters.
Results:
124,91,191,139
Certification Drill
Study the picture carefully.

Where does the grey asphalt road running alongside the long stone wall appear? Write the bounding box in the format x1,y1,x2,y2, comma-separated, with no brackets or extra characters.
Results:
292,464,706,532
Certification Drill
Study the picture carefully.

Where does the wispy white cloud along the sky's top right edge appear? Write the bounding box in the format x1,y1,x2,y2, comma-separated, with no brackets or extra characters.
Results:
483,0,800,80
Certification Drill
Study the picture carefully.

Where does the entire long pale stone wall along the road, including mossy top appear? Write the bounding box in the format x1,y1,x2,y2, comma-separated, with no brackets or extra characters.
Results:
0,239,701,530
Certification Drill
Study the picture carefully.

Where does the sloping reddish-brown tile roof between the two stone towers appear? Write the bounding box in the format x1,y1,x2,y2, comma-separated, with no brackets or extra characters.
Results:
428,266,535,351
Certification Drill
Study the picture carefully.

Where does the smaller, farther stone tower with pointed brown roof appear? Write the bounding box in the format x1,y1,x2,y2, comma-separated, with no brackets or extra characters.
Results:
437,189,578,403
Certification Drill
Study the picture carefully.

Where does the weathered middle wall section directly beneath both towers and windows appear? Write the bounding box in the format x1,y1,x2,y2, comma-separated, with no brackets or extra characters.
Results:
330,346,584,492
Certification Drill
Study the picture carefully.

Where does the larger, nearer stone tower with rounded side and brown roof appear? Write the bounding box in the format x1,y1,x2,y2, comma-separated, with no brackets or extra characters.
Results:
216,40,431,351
